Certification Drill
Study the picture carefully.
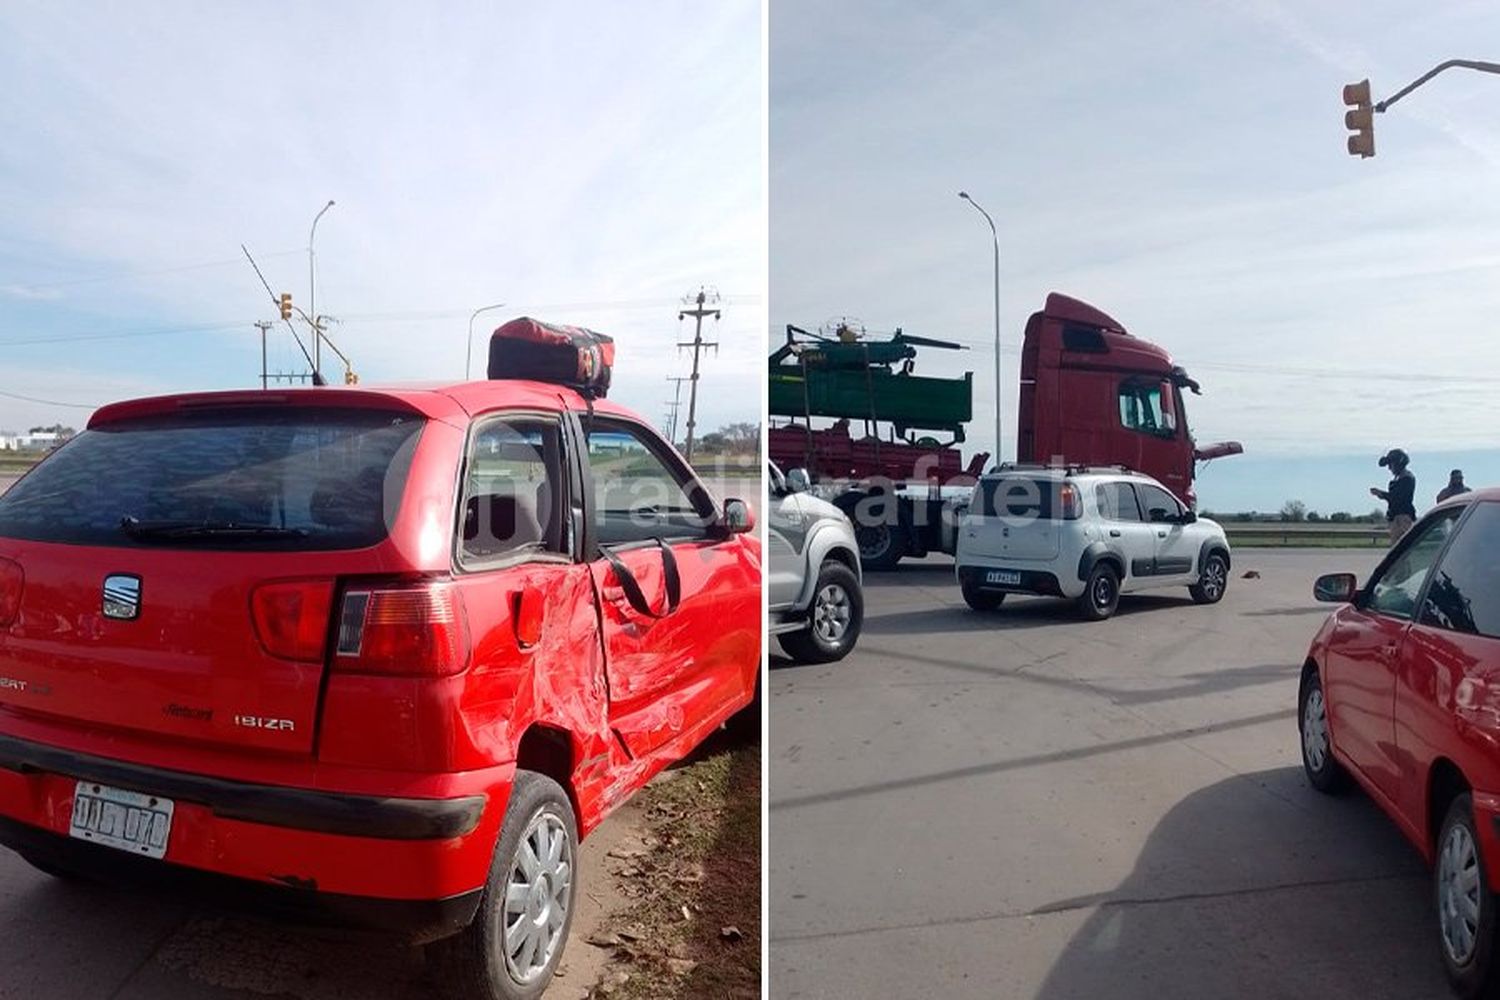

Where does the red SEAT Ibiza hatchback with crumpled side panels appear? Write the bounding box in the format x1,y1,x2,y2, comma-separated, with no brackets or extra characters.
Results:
0,350,761,999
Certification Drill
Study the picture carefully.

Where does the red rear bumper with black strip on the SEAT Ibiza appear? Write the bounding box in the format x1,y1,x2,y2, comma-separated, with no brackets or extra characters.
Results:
0,736,515,917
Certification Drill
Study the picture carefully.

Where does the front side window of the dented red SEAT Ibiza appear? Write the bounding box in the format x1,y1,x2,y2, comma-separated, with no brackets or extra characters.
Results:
588,420,714,544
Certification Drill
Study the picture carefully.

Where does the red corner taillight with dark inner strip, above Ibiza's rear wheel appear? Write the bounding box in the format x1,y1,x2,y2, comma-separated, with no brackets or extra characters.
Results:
333,583,468,678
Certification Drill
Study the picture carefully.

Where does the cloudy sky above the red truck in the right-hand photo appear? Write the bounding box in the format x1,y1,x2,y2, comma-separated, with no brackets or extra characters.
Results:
770,0,1500,511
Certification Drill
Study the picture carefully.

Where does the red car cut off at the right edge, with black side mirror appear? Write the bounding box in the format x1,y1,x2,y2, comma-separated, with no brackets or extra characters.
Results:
1298,490,1500,997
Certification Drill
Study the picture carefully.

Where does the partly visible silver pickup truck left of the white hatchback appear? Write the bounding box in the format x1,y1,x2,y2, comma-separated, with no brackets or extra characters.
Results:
767,463,864,663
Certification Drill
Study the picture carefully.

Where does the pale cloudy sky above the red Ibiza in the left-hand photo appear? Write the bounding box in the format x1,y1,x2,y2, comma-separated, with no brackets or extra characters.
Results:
0,0,767,436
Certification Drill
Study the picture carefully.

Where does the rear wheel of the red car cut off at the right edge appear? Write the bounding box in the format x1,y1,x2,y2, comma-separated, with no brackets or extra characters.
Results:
1433,792,1500,1000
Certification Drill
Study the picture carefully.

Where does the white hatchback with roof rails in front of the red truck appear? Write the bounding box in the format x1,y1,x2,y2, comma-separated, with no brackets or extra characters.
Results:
956,465,1230,621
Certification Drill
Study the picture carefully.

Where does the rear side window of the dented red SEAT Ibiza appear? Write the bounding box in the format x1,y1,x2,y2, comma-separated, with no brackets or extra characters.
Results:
459,417,570,567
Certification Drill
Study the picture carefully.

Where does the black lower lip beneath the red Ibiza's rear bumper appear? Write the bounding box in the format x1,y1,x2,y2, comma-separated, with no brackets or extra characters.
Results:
0,816,482,942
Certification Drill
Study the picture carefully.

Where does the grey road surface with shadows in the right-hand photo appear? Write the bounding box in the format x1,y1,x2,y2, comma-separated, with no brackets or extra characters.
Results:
768,550,1448,1000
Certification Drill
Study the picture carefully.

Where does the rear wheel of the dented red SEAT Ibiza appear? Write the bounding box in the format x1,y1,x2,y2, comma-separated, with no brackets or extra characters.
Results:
429,771,578,1000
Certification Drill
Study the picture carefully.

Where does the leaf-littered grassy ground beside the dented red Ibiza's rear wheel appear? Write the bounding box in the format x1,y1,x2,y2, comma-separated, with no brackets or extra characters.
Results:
593,733,761,1000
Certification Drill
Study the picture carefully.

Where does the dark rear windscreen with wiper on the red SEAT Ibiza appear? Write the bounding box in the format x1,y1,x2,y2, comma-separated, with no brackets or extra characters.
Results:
0,408,423,550
